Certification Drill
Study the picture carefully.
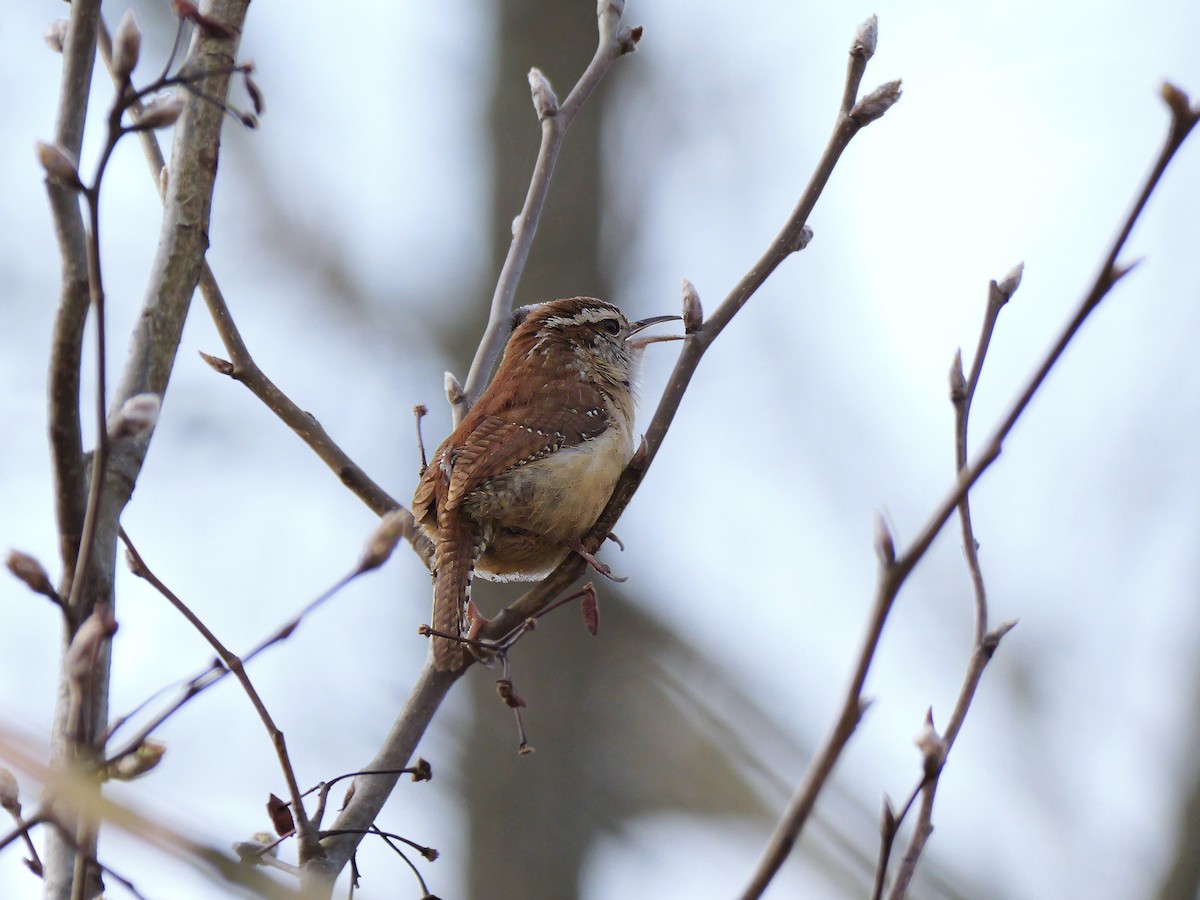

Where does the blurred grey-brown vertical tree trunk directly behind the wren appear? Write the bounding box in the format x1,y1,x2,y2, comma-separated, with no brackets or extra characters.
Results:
458,0,609,900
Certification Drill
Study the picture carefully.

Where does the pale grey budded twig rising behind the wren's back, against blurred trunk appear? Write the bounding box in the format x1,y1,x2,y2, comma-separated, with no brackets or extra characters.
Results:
454,0,642,415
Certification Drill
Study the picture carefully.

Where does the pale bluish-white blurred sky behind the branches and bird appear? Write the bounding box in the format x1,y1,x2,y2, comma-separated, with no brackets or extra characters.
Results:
0,0,1200,899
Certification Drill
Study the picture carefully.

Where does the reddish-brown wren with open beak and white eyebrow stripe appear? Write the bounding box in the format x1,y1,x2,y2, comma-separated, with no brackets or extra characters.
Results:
413,296,679,670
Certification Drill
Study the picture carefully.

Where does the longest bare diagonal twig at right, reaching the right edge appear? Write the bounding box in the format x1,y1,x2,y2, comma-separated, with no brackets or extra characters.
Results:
742,85,1200,899
